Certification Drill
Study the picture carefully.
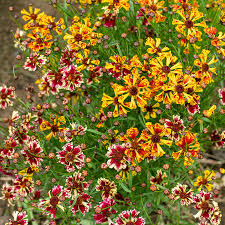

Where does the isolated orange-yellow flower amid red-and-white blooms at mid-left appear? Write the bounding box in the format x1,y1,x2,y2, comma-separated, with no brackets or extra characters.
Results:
40,114,66,142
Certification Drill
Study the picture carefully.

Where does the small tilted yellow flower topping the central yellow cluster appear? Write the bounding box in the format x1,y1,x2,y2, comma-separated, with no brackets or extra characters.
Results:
145,37,169,56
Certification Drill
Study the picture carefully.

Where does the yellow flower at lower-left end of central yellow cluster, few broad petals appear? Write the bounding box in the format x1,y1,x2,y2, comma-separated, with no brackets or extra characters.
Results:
101,90,127,117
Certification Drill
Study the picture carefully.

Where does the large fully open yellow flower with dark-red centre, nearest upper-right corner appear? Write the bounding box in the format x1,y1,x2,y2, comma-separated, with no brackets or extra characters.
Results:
172,8,206,37
